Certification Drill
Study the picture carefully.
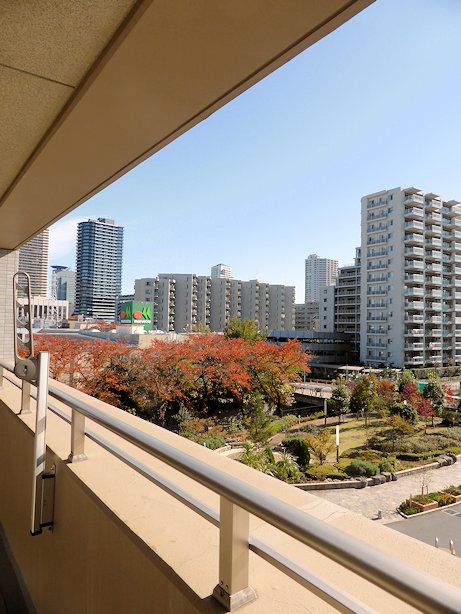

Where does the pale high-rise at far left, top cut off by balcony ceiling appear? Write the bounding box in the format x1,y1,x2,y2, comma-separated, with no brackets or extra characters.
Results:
19,228,50,296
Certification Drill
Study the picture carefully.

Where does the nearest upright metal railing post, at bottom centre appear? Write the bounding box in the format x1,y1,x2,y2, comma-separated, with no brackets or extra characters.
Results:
213,497,256,612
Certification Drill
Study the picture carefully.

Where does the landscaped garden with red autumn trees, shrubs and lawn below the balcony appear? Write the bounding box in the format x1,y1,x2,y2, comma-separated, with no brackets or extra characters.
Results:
36,320,461,483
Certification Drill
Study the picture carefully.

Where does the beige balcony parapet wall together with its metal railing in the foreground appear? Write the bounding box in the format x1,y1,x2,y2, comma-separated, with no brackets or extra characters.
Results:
4,356,461,612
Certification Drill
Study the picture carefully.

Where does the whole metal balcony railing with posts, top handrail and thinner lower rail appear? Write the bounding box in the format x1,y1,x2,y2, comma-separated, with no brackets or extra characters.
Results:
0,357,461,614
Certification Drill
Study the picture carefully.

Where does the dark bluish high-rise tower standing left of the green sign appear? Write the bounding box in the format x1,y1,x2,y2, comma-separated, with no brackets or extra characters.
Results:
75,218,123,321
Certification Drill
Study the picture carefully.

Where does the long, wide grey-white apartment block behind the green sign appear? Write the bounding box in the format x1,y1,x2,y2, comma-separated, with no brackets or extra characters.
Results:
134,273,295,332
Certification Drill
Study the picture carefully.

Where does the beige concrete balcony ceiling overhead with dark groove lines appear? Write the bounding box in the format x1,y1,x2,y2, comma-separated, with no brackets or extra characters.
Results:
0,0,372,249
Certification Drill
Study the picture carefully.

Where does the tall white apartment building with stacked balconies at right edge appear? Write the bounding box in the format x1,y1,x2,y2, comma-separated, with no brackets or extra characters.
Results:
360,187,461,367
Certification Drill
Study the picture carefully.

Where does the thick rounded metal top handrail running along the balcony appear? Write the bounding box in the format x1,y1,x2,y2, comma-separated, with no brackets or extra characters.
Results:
0,361,461,614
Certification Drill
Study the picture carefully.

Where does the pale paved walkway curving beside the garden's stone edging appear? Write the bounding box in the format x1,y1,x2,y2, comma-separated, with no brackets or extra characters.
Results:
309,461,461,522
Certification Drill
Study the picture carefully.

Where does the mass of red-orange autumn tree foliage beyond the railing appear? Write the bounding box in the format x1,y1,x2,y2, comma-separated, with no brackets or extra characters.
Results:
36,334,309,423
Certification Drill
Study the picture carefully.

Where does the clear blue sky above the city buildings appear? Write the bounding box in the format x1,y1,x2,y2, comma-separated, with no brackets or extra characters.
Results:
50,0,461,302
